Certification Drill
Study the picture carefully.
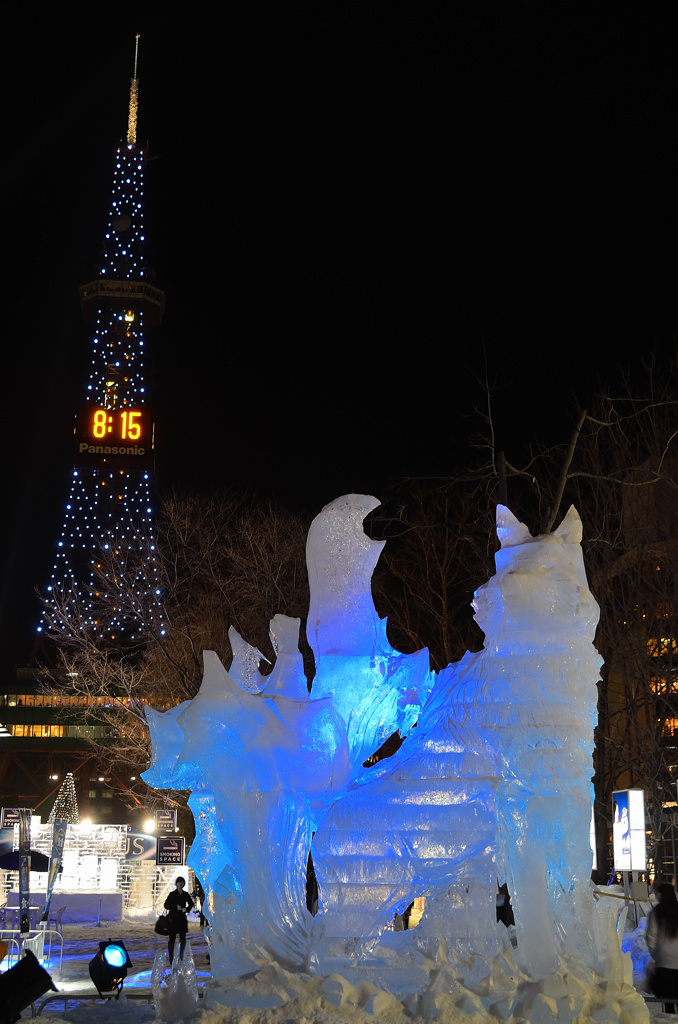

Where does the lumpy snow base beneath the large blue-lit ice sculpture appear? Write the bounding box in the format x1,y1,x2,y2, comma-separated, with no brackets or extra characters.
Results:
204,952,649,1024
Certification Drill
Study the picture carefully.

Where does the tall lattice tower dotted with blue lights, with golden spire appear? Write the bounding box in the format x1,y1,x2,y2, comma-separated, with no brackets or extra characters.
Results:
39,36,165,640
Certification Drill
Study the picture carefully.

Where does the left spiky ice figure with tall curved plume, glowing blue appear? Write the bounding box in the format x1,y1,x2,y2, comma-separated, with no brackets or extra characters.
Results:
144,495,433,976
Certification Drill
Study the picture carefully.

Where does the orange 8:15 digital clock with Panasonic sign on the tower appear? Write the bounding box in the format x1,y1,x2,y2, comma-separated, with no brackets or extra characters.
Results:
75,406,154,462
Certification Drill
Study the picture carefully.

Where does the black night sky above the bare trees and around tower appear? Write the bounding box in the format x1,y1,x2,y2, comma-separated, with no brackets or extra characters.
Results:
0,9,678,671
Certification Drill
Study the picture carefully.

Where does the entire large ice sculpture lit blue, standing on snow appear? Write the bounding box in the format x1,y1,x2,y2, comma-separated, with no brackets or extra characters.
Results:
144,495,619,991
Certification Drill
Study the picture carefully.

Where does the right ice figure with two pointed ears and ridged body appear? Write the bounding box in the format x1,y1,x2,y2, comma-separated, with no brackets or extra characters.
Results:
313,506,601,977
